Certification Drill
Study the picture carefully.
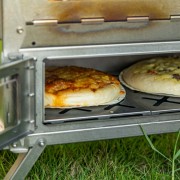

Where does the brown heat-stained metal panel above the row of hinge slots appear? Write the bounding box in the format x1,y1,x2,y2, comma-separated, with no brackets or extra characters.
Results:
19,0,180,22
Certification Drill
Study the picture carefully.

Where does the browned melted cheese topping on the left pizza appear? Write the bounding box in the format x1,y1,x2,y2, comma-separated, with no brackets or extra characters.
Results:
45,66,120,94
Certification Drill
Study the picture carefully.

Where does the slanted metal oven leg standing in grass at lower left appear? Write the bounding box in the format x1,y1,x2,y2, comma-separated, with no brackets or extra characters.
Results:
4,141,46,180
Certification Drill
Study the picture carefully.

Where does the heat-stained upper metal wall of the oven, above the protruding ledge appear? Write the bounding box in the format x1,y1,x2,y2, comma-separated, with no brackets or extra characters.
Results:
1,0,180,56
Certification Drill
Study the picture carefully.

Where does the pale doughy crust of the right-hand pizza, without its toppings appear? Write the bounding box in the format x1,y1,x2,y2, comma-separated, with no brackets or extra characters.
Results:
121,60,180,96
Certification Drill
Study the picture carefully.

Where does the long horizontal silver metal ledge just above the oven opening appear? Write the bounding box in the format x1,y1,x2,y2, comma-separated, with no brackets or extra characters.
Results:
19,40,180,61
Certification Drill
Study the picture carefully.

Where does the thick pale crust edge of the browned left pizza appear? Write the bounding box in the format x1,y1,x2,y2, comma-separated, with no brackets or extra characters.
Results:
44,84,121,107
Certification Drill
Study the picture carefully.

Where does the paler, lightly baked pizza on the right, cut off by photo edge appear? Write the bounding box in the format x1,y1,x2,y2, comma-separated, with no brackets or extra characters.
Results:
121,57,180,96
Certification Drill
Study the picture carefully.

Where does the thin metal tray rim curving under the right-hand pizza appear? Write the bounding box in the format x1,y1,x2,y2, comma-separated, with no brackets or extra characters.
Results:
119,71,180,97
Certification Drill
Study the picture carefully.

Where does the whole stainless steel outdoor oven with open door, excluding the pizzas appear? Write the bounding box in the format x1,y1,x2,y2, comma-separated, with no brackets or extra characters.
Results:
0,0,180,179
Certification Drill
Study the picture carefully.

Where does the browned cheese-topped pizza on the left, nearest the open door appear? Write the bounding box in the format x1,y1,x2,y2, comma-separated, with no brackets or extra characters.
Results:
44,66,126,108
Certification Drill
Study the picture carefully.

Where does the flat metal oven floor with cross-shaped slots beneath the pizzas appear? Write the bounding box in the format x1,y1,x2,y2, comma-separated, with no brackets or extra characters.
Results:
44,89,180,123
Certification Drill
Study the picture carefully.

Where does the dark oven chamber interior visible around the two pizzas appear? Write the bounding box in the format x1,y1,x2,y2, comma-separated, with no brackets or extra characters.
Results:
44,54,180,124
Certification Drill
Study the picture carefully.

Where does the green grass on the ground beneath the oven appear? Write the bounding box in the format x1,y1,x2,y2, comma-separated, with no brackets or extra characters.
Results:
0,133,180,180
